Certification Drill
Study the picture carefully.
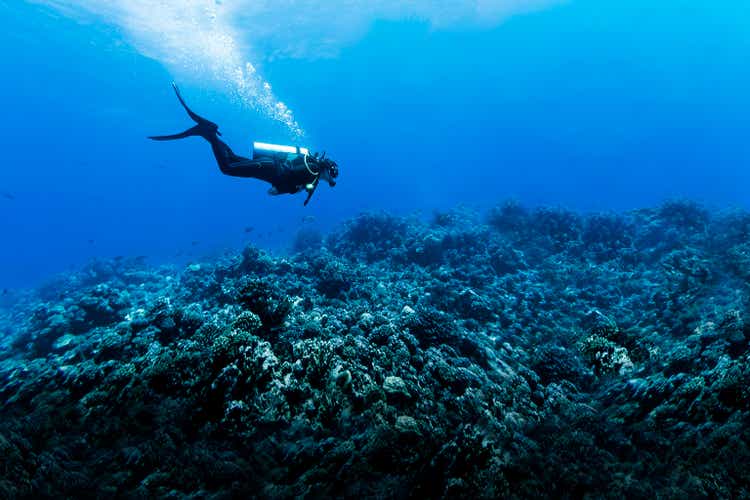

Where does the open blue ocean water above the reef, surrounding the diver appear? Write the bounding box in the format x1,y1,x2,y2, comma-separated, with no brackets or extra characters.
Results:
0,0,750,288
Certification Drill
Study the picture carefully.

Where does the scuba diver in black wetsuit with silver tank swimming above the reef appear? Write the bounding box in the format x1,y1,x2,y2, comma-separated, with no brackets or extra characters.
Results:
149,83,339,205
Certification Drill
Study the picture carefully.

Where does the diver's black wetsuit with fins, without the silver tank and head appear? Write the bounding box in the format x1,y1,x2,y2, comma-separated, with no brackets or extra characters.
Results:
149,84,320,205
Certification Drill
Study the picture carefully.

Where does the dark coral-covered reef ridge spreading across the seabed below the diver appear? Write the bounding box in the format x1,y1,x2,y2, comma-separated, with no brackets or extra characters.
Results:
0,201,750,499
